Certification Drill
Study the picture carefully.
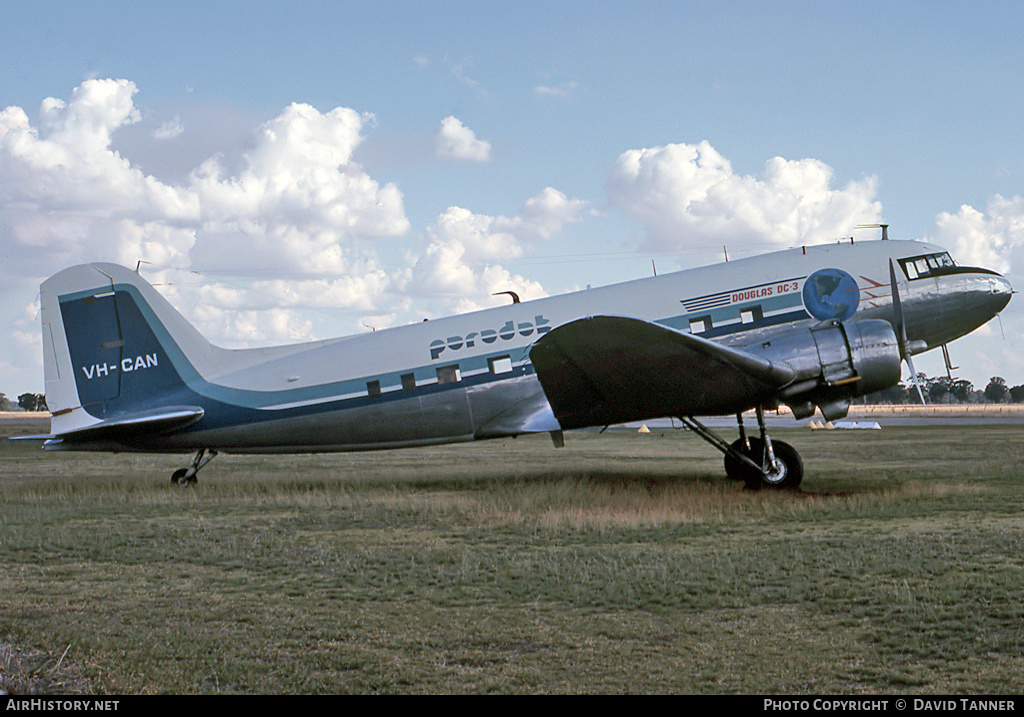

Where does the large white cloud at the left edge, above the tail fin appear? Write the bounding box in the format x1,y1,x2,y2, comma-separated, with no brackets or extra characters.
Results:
0,80,200,278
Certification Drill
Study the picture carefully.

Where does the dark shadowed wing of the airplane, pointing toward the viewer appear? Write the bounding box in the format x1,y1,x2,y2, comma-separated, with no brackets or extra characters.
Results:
529,317,796,429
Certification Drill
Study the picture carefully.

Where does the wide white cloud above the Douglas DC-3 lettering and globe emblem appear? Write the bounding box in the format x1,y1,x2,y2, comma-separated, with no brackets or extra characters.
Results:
606,141,882,249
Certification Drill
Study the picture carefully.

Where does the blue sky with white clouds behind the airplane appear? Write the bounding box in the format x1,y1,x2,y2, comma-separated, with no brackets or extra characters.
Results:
0,0,1024,397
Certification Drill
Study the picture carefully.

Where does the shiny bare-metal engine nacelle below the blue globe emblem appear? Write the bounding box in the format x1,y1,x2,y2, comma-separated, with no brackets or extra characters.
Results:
746,320,900,421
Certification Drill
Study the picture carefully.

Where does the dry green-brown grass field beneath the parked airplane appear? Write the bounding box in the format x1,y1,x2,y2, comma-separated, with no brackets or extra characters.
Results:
0,424,1024,693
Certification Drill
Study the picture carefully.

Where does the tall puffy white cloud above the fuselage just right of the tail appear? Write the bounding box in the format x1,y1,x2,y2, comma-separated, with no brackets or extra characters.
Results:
190,104,410,275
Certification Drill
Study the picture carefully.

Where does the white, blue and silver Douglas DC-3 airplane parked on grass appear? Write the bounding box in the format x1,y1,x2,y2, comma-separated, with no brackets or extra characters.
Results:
40,227,1013,489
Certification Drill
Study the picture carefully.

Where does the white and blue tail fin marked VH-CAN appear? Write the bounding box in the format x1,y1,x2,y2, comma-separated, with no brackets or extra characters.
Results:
40,263,217,434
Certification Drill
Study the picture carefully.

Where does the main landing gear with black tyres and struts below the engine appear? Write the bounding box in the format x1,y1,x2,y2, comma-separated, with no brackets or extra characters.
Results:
680,407,804,490
